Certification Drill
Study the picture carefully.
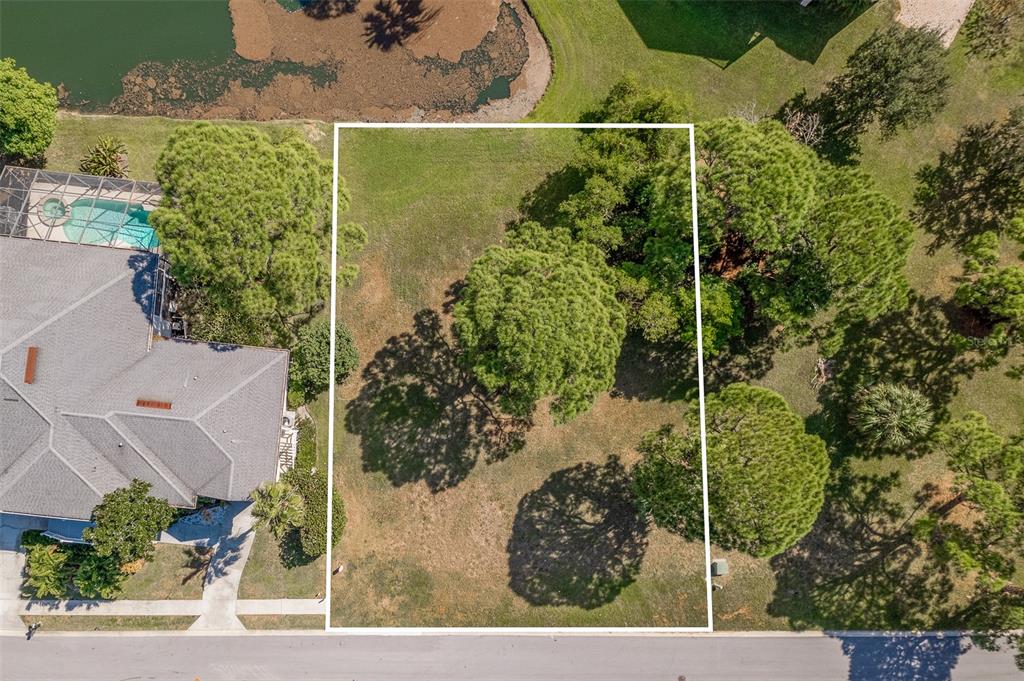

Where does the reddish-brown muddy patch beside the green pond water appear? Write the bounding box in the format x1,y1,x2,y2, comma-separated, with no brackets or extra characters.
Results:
111,0,551,121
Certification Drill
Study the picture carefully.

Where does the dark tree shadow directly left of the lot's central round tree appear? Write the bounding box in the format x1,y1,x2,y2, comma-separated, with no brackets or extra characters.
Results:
345,309,532,493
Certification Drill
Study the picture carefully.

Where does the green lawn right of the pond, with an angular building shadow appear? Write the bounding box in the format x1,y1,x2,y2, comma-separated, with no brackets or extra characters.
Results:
528,0,888,121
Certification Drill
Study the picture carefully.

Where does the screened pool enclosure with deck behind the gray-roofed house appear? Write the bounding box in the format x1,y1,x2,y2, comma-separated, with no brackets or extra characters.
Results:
0,166,162,251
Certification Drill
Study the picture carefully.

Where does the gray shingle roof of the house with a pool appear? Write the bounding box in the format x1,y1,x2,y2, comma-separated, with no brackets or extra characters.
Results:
0,239,288,519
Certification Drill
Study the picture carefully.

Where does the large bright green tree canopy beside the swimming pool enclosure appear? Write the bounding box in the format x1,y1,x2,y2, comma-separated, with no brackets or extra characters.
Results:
150,123,366,342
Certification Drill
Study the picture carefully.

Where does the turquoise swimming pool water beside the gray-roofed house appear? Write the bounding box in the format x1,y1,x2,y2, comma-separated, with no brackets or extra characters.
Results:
63,199,160,251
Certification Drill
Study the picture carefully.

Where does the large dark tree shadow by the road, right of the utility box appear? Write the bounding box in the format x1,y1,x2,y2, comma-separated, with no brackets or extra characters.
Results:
768,463,953,630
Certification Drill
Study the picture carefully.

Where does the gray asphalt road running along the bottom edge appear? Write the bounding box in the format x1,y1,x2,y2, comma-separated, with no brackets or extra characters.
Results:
0,632,1024,681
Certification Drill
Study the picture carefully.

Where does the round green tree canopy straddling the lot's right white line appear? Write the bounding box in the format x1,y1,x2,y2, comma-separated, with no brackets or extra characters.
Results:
634,383,828,557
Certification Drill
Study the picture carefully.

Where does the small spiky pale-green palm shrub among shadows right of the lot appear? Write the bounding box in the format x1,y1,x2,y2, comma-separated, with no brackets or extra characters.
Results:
853,383,935,449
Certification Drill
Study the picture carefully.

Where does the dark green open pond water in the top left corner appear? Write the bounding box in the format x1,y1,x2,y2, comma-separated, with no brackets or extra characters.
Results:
0,0,234,109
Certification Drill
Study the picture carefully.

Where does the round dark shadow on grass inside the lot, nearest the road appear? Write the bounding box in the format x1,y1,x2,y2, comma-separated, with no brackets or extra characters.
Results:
508,457,647,609
